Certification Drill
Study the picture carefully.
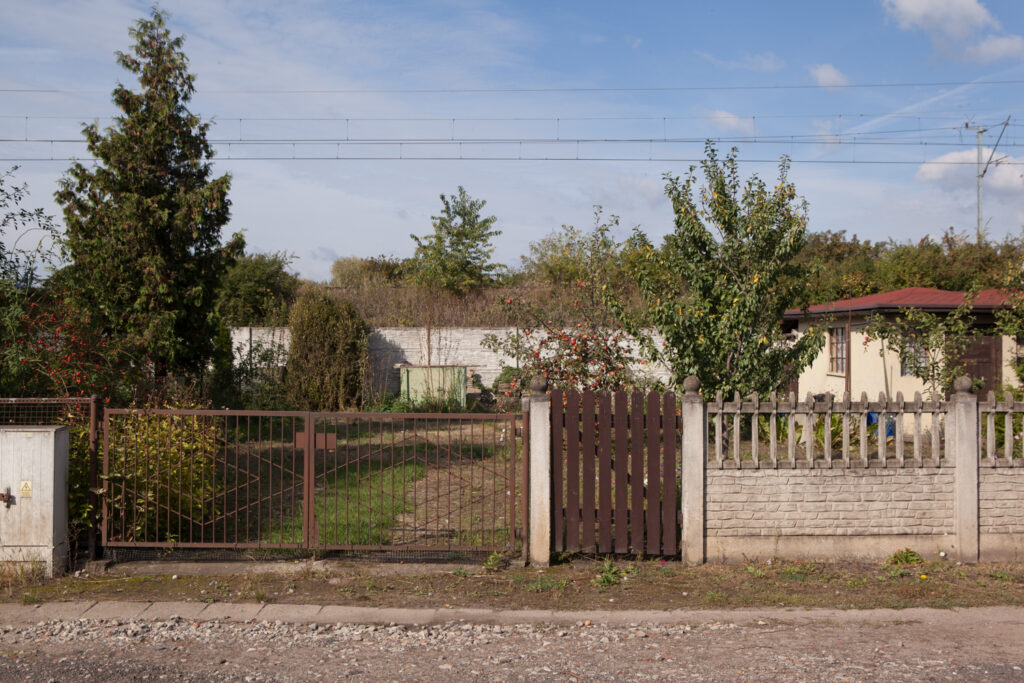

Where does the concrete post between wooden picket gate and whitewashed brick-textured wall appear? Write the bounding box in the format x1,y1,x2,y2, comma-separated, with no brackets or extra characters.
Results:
681,376,708,564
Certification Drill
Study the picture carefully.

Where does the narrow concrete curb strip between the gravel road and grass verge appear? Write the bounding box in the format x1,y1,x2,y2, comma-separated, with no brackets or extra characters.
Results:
0,601,1024,626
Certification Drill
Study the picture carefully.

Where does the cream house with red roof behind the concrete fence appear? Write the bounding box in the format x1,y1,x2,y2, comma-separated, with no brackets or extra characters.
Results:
784,287,1018,400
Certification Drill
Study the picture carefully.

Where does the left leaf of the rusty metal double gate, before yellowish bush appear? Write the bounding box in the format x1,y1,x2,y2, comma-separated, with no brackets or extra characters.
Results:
102,410,309,548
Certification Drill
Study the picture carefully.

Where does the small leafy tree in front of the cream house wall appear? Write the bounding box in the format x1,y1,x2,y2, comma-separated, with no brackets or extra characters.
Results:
864,294,978,400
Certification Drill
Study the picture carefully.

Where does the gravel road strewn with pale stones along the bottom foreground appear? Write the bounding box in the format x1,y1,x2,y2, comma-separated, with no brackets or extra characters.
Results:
0,612,1024,681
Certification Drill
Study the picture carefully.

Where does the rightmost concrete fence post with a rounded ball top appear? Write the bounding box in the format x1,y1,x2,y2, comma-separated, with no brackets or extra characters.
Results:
946,377,980,563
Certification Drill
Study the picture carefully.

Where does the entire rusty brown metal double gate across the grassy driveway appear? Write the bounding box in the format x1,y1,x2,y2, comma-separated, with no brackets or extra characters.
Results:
102,410,526,554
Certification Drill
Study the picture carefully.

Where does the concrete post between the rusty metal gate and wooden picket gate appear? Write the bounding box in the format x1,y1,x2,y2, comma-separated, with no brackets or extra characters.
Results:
526,376,552,567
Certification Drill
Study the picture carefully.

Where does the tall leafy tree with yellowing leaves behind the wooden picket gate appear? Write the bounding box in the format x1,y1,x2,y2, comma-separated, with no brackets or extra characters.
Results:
605,143,824,396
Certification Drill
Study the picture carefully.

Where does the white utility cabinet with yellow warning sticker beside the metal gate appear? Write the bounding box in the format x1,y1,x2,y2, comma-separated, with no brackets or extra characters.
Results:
0,426,69,577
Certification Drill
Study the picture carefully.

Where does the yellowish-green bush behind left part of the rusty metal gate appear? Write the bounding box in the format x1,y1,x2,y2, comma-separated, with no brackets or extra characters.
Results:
108,402,223,542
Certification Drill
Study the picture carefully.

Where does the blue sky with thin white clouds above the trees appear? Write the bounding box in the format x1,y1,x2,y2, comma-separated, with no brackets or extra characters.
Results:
0,0,1024,280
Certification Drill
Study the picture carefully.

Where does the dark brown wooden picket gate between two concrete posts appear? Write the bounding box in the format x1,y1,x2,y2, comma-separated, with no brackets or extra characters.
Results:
550,389,681,556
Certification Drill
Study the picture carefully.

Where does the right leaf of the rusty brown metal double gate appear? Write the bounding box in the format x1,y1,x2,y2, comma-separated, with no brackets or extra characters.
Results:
310,413,522,552
